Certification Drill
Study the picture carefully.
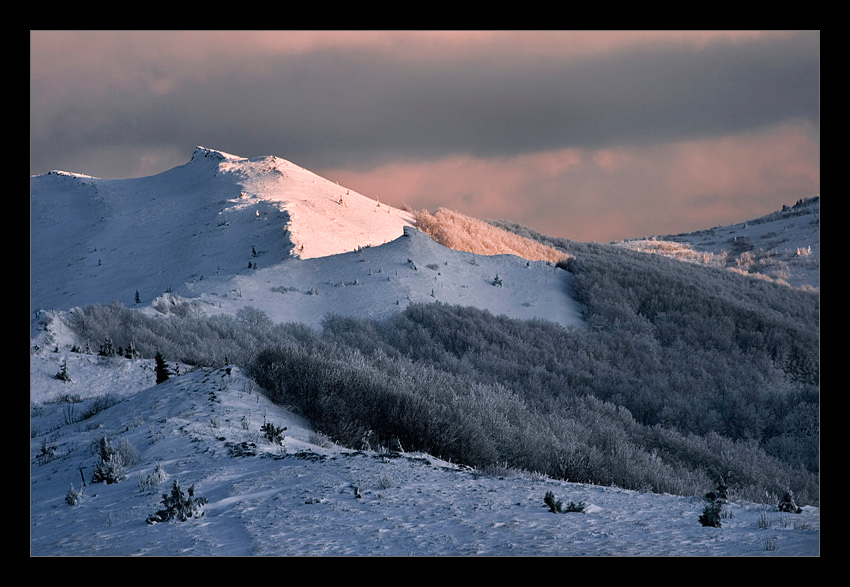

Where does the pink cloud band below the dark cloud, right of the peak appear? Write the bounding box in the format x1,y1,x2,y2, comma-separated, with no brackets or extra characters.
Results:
319,125,820,242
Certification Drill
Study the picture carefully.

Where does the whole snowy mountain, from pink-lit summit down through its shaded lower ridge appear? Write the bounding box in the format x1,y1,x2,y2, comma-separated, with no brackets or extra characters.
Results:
31,147,581,336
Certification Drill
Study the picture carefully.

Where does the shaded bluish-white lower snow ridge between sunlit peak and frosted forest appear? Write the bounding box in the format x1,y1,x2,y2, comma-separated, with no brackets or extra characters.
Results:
188,227,582,326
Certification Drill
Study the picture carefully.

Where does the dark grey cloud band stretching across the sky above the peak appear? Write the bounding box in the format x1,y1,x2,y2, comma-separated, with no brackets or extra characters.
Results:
32,33,819,173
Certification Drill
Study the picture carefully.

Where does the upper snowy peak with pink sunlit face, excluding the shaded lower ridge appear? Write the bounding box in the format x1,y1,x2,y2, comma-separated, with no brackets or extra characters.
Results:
30,147,410,310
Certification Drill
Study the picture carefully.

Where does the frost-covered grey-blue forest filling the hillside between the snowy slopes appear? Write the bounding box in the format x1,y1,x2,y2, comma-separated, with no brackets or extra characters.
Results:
59,227,819,505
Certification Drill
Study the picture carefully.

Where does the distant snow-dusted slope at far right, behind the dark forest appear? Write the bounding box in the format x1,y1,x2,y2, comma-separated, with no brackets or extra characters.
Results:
616,196,820,290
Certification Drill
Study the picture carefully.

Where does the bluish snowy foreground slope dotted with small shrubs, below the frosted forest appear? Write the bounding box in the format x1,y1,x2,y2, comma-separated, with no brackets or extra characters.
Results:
30,349,820,556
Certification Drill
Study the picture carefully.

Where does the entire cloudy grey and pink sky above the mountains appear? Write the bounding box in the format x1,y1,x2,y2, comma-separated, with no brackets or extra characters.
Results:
30,31,820,242
